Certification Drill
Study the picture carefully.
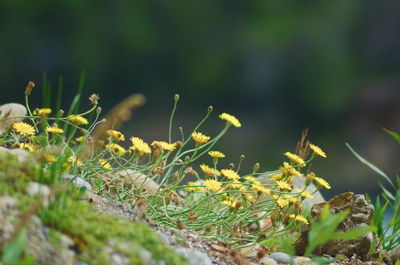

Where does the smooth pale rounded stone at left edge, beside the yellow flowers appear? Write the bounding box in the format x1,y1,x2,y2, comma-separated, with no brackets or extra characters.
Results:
0,103,27,135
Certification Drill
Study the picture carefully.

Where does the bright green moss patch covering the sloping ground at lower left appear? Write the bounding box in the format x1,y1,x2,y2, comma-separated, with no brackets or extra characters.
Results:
0,153,188,264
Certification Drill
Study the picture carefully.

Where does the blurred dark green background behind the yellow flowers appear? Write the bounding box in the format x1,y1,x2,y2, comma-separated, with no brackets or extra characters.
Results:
0,0,400,198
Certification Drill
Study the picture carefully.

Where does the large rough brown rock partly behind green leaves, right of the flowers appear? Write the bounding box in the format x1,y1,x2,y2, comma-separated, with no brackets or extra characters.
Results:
296,192,375,259
